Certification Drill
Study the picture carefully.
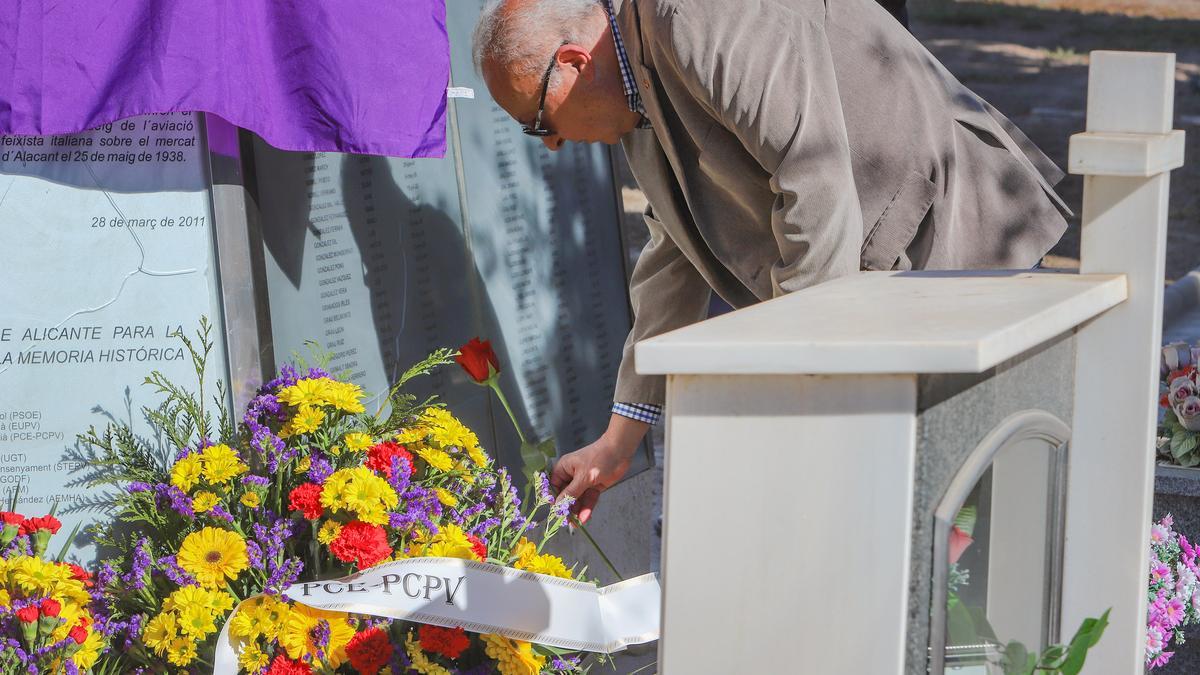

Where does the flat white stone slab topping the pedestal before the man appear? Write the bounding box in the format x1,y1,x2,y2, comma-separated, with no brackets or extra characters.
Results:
636,271,1128,375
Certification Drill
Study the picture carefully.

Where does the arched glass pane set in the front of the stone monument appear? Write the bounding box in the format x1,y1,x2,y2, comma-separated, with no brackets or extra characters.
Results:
944,432,1058,674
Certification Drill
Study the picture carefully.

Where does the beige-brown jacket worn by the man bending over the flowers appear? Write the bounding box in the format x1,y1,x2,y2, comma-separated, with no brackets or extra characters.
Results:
614,0,1067,404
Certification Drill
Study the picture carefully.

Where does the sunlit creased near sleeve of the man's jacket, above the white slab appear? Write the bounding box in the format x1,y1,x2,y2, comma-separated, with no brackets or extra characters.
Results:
650,1,863,295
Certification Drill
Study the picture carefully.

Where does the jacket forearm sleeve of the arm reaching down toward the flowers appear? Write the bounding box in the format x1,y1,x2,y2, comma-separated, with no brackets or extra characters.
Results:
613,208,712,406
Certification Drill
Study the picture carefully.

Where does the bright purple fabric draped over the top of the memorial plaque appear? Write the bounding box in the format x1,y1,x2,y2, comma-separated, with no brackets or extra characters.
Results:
0,0,450,157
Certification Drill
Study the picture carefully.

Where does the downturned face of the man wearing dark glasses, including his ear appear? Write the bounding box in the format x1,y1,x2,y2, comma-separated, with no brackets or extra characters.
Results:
484,44,638,150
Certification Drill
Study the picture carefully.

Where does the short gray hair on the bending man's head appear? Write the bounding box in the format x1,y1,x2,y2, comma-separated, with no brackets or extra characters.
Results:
473,0,604,80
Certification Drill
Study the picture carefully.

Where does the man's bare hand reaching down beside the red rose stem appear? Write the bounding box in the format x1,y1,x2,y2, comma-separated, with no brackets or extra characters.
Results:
550,414,650,522
